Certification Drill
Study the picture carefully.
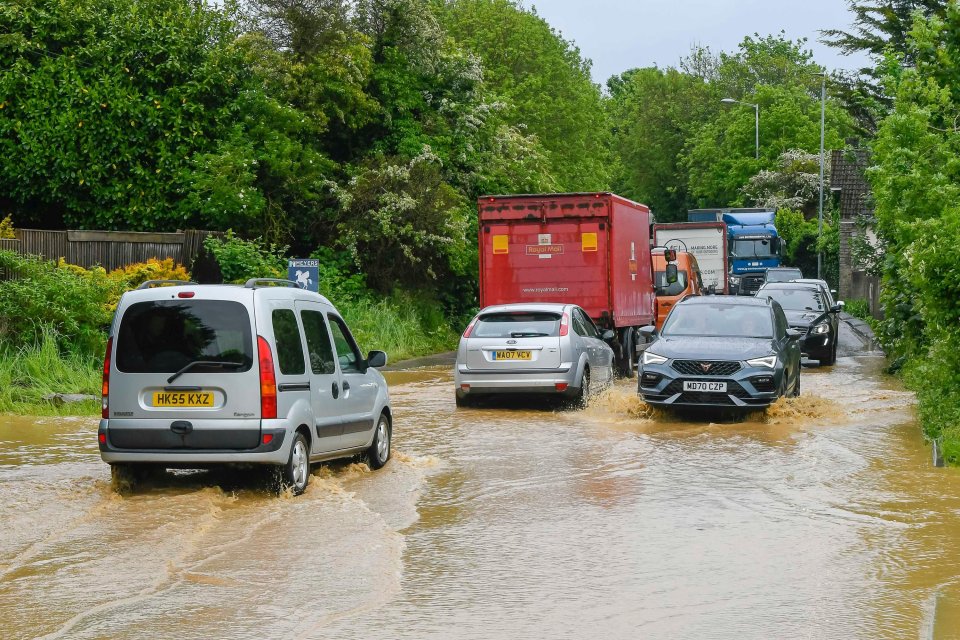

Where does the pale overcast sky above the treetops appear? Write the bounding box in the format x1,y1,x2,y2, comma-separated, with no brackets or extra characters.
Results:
523,0,865,84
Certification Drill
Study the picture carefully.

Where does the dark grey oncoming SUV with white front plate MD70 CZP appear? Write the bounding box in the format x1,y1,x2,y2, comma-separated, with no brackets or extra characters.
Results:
638,296,800,408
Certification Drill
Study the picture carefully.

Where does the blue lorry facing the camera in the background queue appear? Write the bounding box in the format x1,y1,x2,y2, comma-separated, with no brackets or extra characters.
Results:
687,209,780,296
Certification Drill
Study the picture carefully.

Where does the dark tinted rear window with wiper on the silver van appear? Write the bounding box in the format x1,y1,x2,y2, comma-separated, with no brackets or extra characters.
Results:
116,300,253,373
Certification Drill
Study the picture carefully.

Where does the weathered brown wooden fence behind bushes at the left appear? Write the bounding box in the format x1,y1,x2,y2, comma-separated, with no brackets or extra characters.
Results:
0,229,222,271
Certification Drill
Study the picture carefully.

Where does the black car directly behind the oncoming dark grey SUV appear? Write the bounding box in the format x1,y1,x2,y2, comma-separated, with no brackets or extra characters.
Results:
757,282,842,365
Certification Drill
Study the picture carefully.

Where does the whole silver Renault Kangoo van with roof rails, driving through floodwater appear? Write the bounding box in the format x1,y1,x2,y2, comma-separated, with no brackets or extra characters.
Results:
97,279,392,494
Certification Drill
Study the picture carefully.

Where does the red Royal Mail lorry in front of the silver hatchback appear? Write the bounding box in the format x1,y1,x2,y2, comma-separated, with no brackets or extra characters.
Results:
478,193,656,377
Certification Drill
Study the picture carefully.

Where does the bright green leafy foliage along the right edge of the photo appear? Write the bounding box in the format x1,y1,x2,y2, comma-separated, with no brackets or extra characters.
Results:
869,3,960,462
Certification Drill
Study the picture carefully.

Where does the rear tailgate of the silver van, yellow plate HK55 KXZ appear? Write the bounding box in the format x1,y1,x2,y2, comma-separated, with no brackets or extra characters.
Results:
108,287,260,450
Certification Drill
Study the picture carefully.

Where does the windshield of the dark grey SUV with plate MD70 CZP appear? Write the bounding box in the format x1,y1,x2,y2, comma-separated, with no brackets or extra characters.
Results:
660,303,773,338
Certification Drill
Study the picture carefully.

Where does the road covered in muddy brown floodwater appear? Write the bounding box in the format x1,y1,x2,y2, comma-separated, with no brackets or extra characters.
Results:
0,324,960,639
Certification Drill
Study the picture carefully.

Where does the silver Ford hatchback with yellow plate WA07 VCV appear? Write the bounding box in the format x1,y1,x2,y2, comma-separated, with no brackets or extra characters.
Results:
454,303,614,406
